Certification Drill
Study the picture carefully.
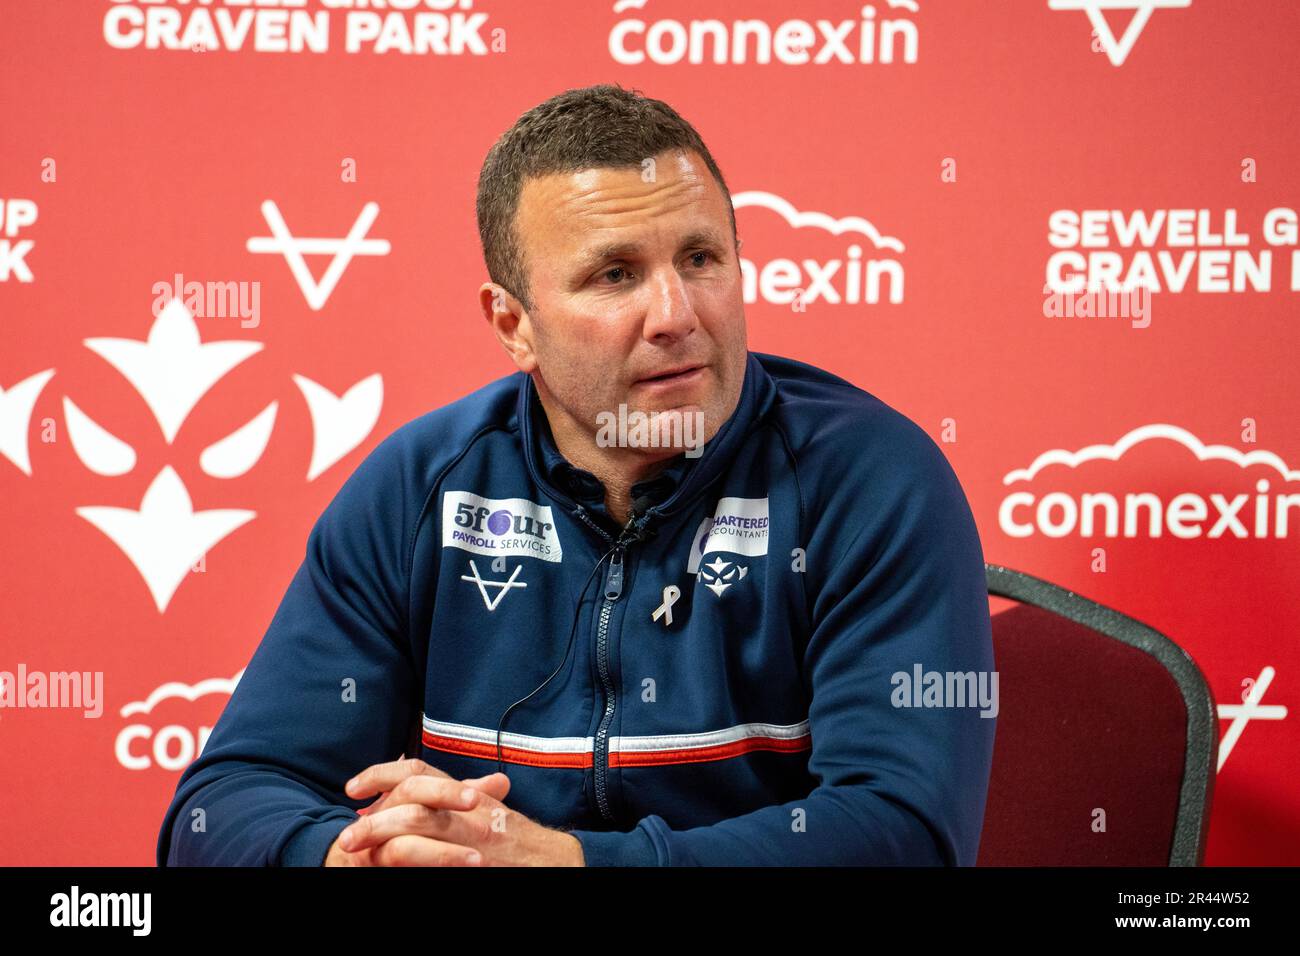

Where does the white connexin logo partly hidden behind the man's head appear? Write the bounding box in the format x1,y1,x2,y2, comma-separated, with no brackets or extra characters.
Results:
732,190,904,312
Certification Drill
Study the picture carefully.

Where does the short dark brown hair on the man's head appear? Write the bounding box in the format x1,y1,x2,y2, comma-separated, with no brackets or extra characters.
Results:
477,83,736,310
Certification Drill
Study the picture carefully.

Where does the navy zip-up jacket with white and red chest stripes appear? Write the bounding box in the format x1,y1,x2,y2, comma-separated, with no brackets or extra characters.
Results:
157,351,996,866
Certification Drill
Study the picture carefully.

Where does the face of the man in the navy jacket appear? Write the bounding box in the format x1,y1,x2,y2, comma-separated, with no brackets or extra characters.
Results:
488,151,748,460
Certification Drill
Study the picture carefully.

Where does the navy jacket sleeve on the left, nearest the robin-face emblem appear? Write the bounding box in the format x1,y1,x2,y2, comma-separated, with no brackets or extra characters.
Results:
157,437,416,866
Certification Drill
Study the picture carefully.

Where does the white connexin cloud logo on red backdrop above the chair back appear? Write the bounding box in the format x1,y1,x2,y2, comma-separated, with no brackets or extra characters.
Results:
997,424,1300,540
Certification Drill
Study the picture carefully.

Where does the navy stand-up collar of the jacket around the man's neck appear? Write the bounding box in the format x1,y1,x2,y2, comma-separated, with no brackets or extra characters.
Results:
516,351,776,535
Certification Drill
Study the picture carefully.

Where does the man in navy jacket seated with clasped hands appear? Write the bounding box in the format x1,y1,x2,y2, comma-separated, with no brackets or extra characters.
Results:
157,86,996,866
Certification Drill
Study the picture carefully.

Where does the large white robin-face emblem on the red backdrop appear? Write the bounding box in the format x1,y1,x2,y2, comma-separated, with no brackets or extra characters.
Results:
0,298,384,614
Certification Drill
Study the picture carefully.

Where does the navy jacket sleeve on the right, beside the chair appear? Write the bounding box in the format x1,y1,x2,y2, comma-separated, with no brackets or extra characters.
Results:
573,425,997,866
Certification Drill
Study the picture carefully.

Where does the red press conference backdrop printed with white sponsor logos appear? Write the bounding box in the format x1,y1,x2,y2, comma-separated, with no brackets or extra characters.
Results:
0,0,1300,865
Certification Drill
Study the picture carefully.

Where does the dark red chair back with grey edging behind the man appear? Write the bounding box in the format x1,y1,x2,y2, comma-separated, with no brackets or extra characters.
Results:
976,564,1218,866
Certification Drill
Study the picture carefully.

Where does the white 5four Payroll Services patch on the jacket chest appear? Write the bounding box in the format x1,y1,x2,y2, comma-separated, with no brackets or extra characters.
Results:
442,492,563,561
